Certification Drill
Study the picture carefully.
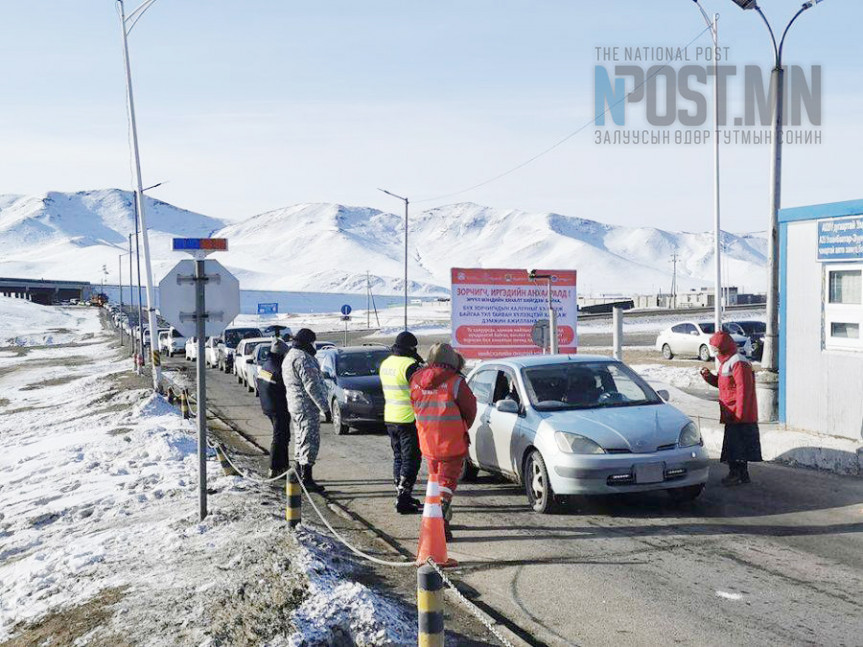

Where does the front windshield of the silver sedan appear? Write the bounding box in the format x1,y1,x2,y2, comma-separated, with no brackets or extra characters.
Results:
524,362,662,411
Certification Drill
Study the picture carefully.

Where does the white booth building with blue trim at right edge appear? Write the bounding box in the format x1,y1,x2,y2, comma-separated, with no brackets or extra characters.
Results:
779,200,863,446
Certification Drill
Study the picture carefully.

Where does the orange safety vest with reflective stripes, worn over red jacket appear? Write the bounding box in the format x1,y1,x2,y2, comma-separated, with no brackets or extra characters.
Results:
411,375,468,460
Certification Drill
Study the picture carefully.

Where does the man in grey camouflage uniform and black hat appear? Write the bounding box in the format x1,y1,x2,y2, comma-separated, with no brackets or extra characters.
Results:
282,328,330,492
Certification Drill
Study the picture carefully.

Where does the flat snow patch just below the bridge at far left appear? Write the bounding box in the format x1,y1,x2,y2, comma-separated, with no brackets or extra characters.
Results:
0,296,100,348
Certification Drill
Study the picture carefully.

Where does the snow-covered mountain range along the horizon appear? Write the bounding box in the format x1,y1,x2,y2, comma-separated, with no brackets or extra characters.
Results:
0,190,766,294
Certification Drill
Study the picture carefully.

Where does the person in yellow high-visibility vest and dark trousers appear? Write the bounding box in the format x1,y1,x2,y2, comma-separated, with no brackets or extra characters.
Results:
379,330,423,514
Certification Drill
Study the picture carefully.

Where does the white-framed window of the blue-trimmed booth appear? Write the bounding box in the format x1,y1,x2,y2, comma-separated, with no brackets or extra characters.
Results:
824,263,863,350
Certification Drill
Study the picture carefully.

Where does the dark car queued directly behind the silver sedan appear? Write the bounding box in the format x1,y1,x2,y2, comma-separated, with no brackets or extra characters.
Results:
317,346,390,434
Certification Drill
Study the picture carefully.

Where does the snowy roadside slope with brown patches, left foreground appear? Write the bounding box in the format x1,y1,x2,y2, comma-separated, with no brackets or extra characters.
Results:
0,309,416,646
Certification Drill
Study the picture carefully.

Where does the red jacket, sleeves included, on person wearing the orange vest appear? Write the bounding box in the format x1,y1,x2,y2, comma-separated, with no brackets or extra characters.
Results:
411,364,476,460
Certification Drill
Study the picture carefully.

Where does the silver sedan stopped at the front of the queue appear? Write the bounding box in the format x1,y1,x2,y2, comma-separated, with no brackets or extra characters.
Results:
463,355,708,513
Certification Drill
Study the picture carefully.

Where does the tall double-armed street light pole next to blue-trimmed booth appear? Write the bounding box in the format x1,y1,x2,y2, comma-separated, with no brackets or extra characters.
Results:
732,0,822,420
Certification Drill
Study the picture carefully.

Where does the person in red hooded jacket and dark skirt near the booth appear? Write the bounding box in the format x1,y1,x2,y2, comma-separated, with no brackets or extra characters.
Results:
701,332,761,485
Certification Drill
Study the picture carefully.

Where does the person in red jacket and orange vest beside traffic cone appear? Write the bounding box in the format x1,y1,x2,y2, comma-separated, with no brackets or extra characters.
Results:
411,344,476,540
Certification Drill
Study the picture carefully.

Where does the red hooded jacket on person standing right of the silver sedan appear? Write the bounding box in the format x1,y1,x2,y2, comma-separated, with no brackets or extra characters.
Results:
703,332,758,425
